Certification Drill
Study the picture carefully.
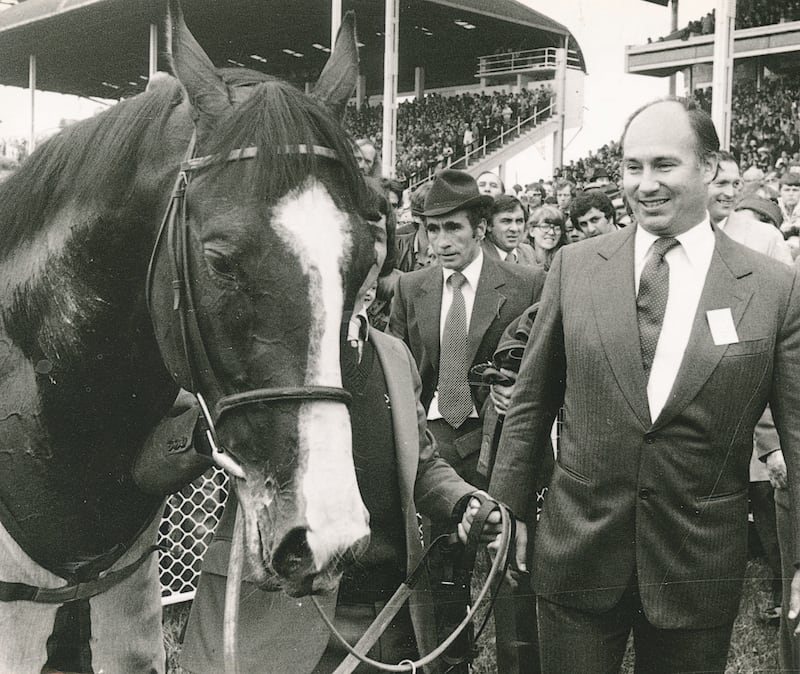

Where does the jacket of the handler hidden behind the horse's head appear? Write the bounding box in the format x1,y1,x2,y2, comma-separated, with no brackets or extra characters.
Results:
181,330,475,674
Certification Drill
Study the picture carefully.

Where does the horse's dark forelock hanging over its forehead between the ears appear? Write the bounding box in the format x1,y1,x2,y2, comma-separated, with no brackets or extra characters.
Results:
201,69,375,215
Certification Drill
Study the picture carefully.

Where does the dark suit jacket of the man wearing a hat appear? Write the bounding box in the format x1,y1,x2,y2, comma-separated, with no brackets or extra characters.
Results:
388,255,545,410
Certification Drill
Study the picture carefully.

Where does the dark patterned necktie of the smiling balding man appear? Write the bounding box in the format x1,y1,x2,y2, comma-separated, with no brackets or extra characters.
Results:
636,237,679,377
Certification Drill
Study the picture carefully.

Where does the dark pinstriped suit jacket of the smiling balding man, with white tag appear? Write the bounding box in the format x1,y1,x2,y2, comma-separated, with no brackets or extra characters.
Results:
490,227,800,628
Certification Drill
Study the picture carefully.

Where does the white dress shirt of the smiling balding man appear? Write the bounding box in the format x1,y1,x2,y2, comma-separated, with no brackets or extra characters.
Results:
634,217,714,421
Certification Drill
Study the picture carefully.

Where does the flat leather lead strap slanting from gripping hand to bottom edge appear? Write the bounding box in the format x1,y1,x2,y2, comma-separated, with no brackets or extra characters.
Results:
333,492,499,674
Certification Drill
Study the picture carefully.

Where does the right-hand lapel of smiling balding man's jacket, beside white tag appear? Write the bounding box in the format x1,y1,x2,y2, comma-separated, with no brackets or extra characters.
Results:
653,231,753,430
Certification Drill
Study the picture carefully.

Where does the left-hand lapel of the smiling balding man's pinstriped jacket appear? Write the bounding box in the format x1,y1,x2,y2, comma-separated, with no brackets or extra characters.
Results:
589,227,650,428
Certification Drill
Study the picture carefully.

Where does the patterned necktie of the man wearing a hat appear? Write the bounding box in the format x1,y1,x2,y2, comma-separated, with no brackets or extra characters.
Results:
439,272,472,428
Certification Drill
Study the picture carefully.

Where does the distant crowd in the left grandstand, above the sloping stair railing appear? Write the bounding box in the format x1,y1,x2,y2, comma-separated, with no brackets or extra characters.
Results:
345,84,553,179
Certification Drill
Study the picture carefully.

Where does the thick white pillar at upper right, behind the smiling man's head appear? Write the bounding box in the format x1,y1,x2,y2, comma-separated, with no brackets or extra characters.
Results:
711,0,736,150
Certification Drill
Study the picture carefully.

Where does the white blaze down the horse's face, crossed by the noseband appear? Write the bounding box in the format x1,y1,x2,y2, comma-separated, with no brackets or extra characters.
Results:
272,179,369,570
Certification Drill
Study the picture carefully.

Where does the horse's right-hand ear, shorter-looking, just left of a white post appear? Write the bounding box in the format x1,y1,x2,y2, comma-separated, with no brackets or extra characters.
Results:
312,12,358,119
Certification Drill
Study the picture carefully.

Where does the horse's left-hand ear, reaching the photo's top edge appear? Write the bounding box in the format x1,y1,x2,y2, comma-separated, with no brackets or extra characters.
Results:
166,0,232,141
